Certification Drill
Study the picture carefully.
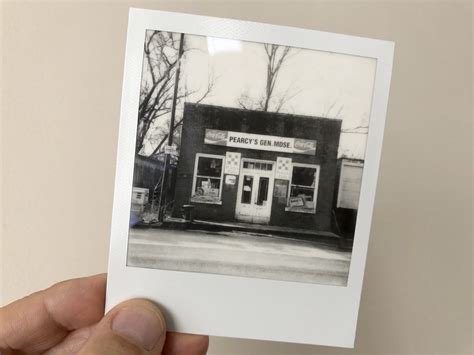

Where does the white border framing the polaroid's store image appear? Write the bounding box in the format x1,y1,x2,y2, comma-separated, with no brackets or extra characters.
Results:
106,8,394,347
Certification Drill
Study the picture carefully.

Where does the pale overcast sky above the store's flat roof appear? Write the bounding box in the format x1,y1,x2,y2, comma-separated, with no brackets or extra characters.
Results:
143,35,376,158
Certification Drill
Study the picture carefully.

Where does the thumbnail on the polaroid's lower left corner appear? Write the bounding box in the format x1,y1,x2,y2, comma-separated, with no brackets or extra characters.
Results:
112,307,165,351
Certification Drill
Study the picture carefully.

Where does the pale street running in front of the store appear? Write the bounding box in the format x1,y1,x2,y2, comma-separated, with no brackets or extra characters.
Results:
127,228,351,286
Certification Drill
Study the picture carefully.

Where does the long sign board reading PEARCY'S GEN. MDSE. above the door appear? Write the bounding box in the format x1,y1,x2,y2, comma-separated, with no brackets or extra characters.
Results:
204,129,316,155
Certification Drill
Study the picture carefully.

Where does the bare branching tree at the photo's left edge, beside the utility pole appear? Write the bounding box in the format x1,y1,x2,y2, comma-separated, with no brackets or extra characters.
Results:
135,31,214,155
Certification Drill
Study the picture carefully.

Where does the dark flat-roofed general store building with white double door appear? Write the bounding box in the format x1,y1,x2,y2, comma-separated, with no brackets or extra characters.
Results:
173,104,342,231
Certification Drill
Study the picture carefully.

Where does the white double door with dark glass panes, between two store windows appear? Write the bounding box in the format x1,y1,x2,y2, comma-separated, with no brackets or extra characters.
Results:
235,159,274,224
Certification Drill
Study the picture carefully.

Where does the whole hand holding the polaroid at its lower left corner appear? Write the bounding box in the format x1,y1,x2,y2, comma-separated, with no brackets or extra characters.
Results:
0,274,209,355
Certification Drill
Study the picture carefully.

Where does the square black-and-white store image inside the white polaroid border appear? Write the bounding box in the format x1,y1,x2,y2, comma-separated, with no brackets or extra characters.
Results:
127,30,376,286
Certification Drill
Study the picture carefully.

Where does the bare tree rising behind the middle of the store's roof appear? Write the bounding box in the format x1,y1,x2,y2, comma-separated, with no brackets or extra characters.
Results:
237,44,299,112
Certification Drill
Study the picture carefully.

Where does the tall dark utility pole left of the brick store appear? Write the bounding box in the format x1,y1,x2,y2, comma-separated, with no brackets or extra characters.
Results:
158,33,184,221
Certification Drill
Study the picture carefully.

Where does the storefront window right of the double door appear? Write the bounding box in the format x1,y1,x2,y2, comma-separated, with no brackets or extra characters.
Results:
286,164,319,213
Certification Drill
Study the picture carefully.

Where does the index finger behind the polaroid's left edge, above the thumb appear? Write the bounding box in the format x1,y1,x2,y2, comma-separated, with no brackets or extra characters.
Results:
0,274,107,353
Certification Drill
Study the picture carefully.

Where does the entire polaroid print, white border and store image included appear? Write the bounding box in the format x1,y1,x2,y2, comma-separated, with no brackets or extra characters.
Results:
106,9,394,347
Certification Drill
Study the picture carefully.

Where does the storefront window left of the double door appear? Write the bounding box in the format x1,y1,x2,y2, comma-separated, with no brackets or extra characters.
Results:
191,154,224,203
